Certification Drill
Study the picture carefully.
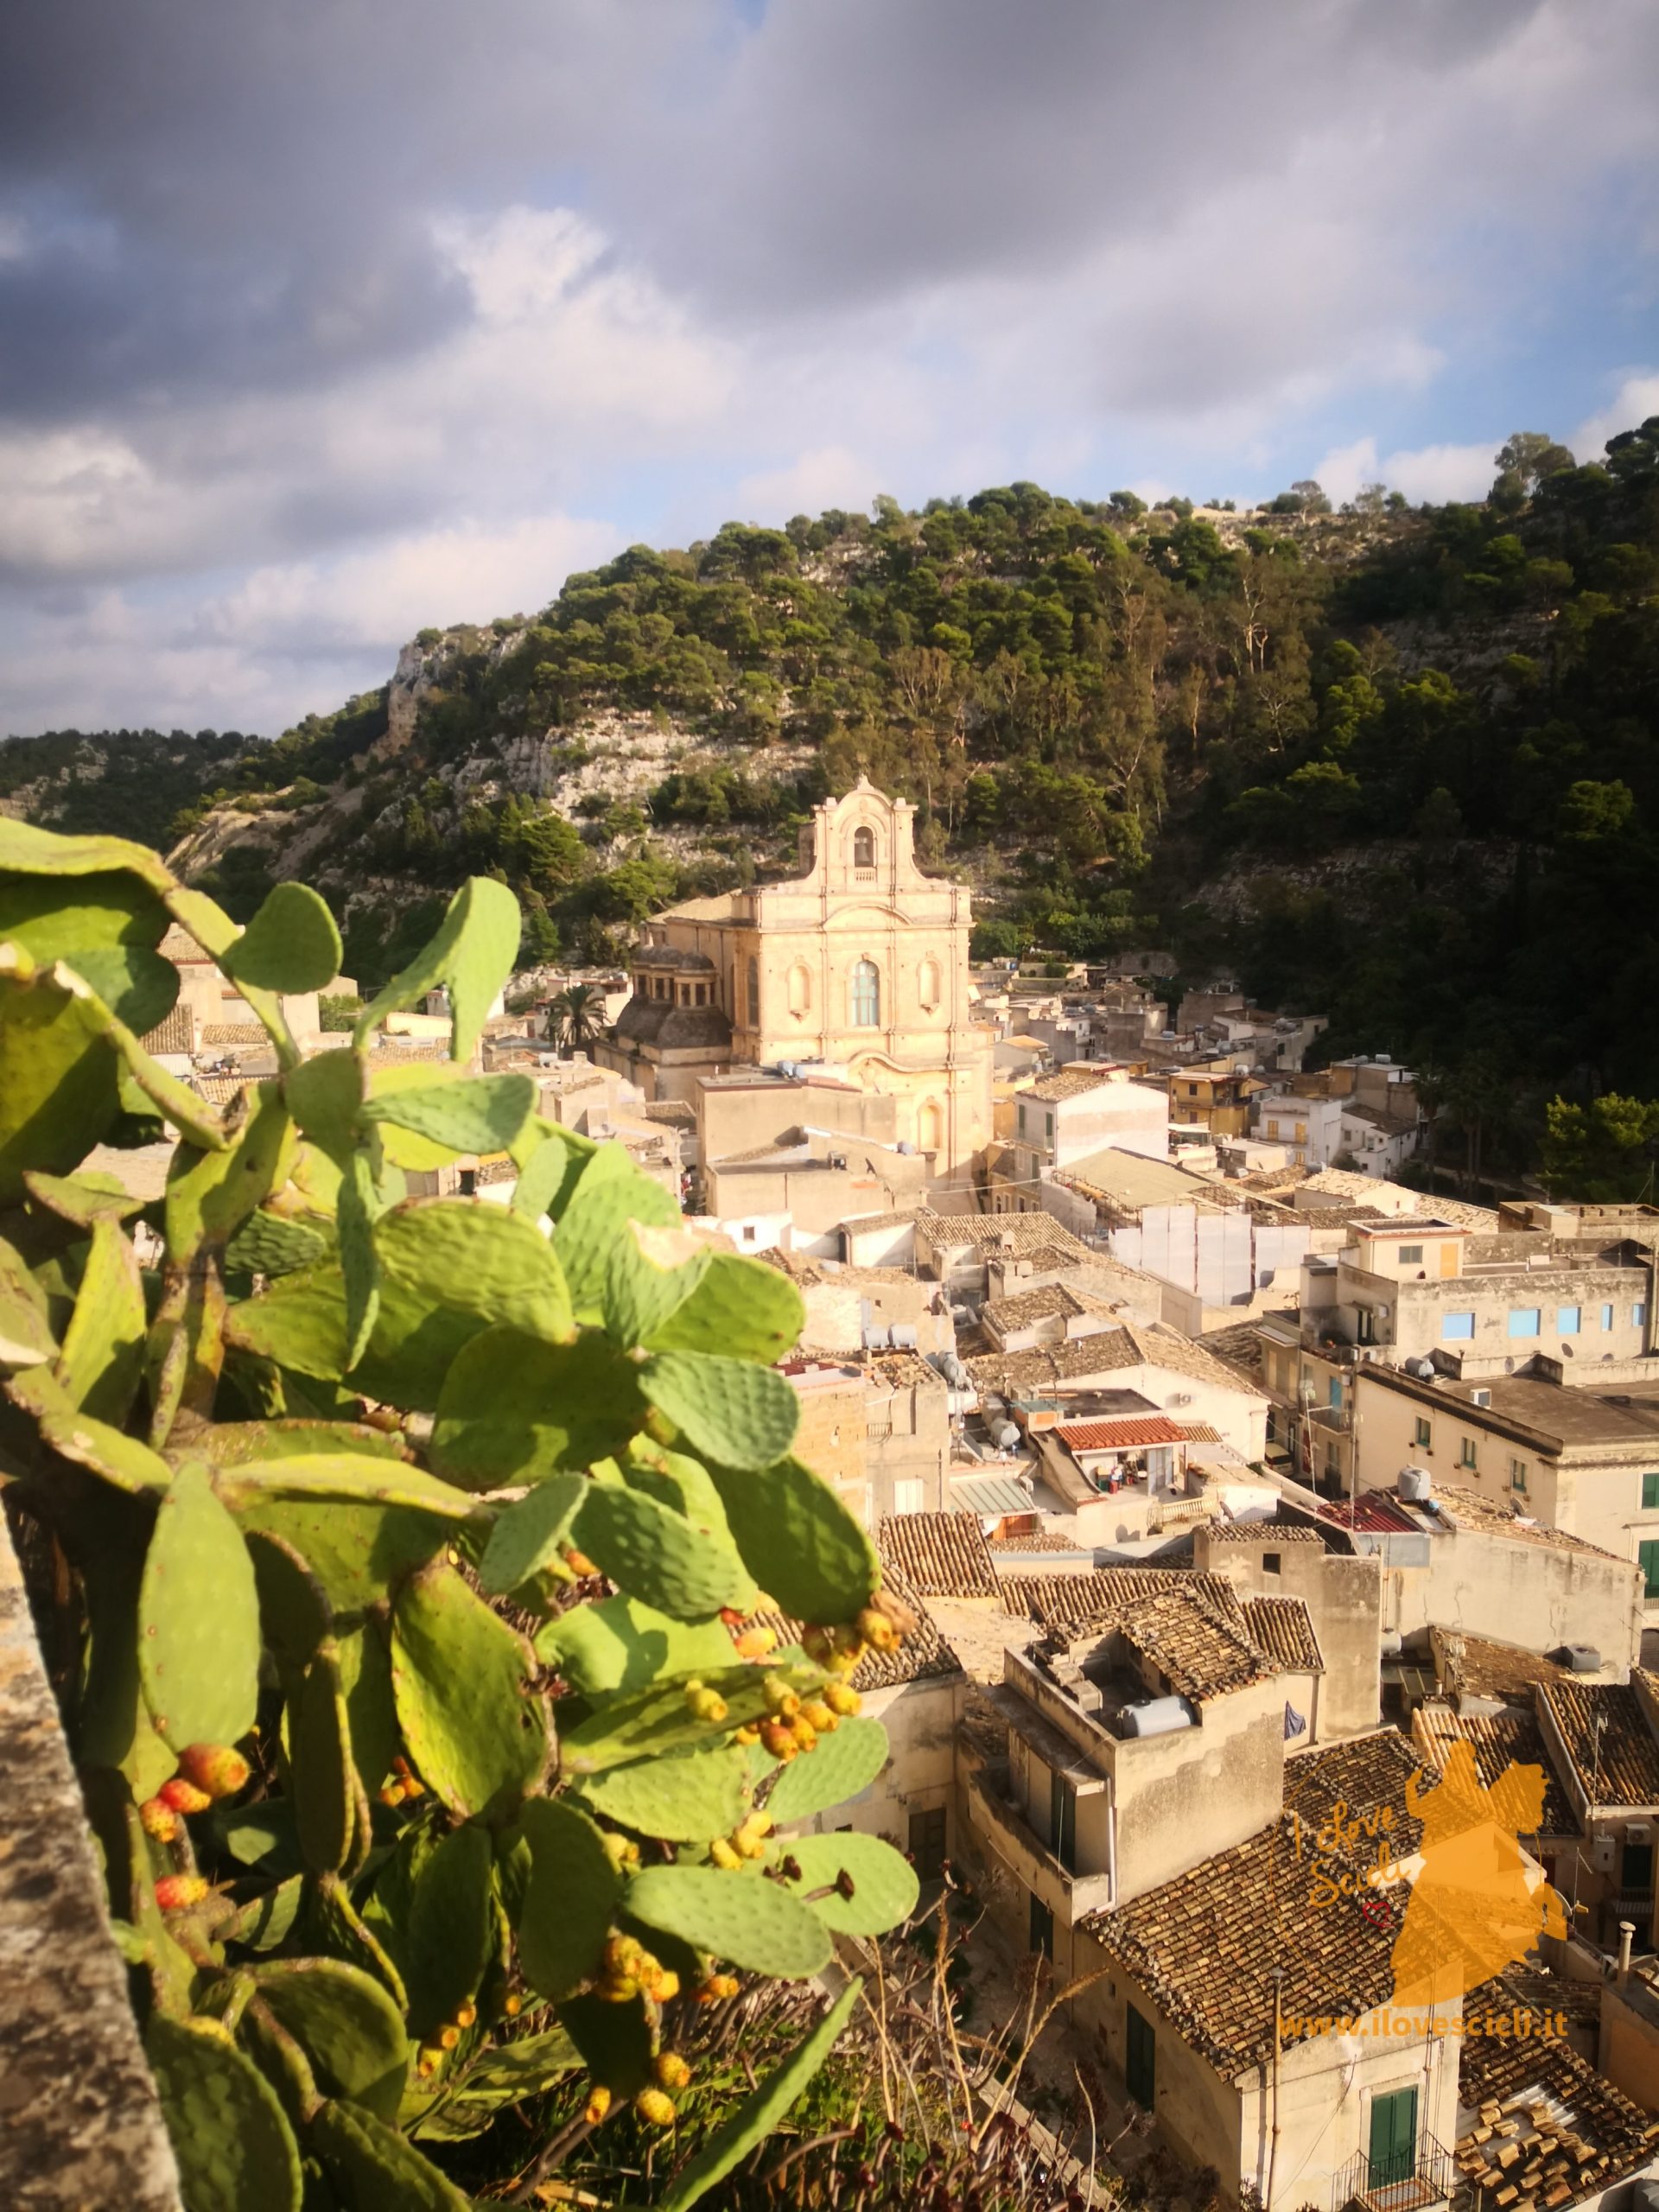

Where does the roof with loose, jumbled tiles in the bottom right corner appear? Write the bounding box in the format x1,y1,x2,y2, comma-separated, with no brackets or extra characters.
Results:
1455,1975,1659,2212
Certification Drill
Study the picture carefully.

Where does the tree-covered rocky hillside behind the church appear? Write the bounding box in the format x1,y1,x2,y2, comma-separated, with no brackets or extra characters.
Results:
13,418,1659,1161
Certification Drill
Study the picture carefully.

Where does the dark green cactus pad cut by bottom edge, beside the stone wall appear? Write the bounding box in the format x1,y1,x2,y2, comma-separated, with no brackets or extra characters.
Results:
143,2013,301,2212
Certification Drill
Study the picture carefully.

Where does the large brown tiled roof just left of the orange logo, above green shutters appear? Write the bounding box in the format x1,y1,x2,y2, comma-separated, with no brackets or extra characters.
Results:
1079,1730,1421,2077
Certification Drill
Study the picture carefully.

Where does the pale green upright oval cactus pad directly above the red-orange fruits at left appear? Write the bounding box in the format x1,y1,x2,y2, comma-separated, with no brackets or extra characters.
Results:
139,1466,259,1752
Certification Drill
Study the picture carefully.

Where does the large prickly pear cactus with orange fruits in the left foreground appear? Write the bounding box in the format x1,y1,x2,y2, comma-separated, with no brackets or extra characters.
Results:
0,821,916,2212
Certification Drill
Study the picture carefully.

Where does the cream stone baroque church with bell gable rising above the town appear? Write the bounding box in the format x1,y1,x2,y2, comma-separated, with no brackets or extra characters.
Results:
595,777,991,1177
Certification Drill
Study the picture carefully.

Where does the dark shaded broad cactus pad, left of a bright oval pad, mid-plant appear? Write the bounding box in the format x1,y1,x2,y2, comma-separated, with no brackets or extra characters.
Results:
431,1327,646,1491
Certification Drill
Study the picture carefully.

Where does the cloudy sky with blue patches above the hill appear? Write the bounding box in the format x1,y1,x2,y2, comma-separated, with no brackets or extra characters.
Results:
0,0,1659,736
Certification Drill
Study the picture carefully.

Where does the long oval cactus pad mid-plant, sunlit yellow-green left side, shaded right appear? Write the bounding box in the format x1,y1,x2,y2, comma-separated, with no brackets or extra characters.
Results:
391,1561,549,1816
